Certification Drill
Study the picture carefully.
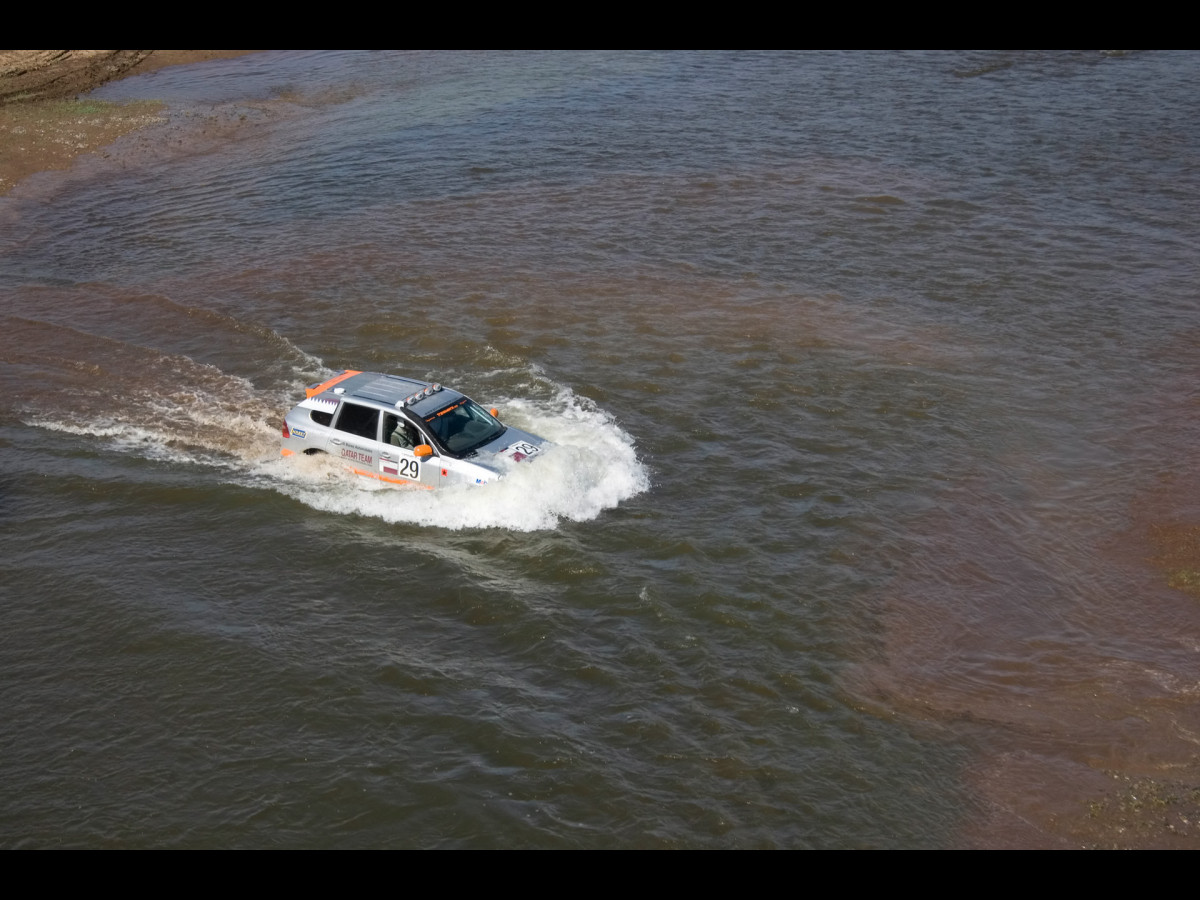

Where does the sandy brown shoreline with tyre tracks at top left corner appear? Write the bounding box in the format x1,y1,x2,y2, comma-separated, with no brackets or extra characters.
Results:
0,50,256,196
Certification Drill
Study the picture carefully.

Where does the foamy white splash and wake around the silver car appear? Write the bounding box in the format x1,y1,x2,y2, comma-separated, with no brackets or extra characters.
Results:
25,377,649,532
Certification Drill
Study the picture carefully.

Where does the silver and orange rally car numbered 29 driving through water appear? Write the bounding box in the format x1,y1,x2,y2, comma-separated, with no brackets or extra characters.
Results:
281,370,547,490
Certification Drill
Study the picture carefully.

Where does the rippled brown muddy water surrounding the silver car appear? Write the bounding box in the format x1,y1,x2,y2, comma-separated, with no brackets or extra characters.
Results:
0,52,1200,848
